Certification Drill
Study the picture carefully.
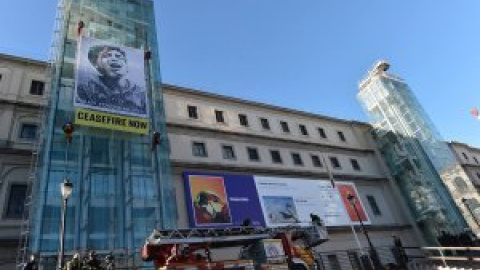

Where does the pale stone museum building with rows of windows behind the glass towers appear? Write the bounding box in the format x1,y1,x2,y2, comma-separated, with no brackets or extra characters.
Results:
0,51,421,264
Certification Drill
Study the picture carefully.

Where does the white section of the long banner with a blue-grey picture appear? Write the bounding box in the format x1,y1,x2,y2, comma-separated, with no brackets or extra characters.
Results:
254,176,369,227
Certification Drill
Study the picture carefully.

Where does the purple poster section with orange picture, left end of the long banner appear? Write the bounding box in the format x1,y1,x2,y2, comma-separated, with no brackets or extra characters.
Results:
184,173,265,227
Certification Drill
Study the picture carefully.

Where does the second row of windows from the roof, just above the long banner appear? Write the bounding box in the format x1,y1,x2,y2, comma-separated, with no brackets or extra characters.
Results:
192,142,361,171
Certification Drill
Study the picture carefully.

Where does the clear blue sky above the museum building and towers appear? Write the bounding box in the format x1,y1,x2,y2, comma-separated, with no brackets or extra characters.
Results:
0,0,480,147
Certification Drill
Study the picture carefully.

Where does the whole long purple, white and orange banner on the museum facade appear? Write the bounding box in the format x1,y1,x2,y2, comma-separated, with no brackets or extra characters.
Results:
184,173,370,227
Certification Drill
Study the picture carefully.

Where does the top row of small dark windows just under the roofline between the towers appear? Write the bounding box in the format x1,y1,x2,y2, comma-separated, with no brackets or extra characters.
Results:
187,105,347,142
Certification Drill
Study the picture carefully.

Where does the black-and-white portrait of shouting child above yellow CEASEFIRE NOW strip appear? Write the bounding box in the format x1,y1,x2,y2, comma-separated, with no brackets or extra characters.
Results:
74,37,148,118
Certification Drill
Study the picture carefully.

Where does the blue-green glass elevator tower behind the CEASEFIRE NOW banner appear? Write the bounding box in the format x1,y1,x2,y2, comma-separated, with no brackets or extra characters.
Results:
21,0,177,266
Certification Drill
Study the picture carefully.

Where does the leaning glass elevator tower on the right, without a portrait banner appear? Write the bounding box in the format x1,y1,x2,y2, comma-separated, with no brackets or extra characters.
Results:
358,61,480,243
